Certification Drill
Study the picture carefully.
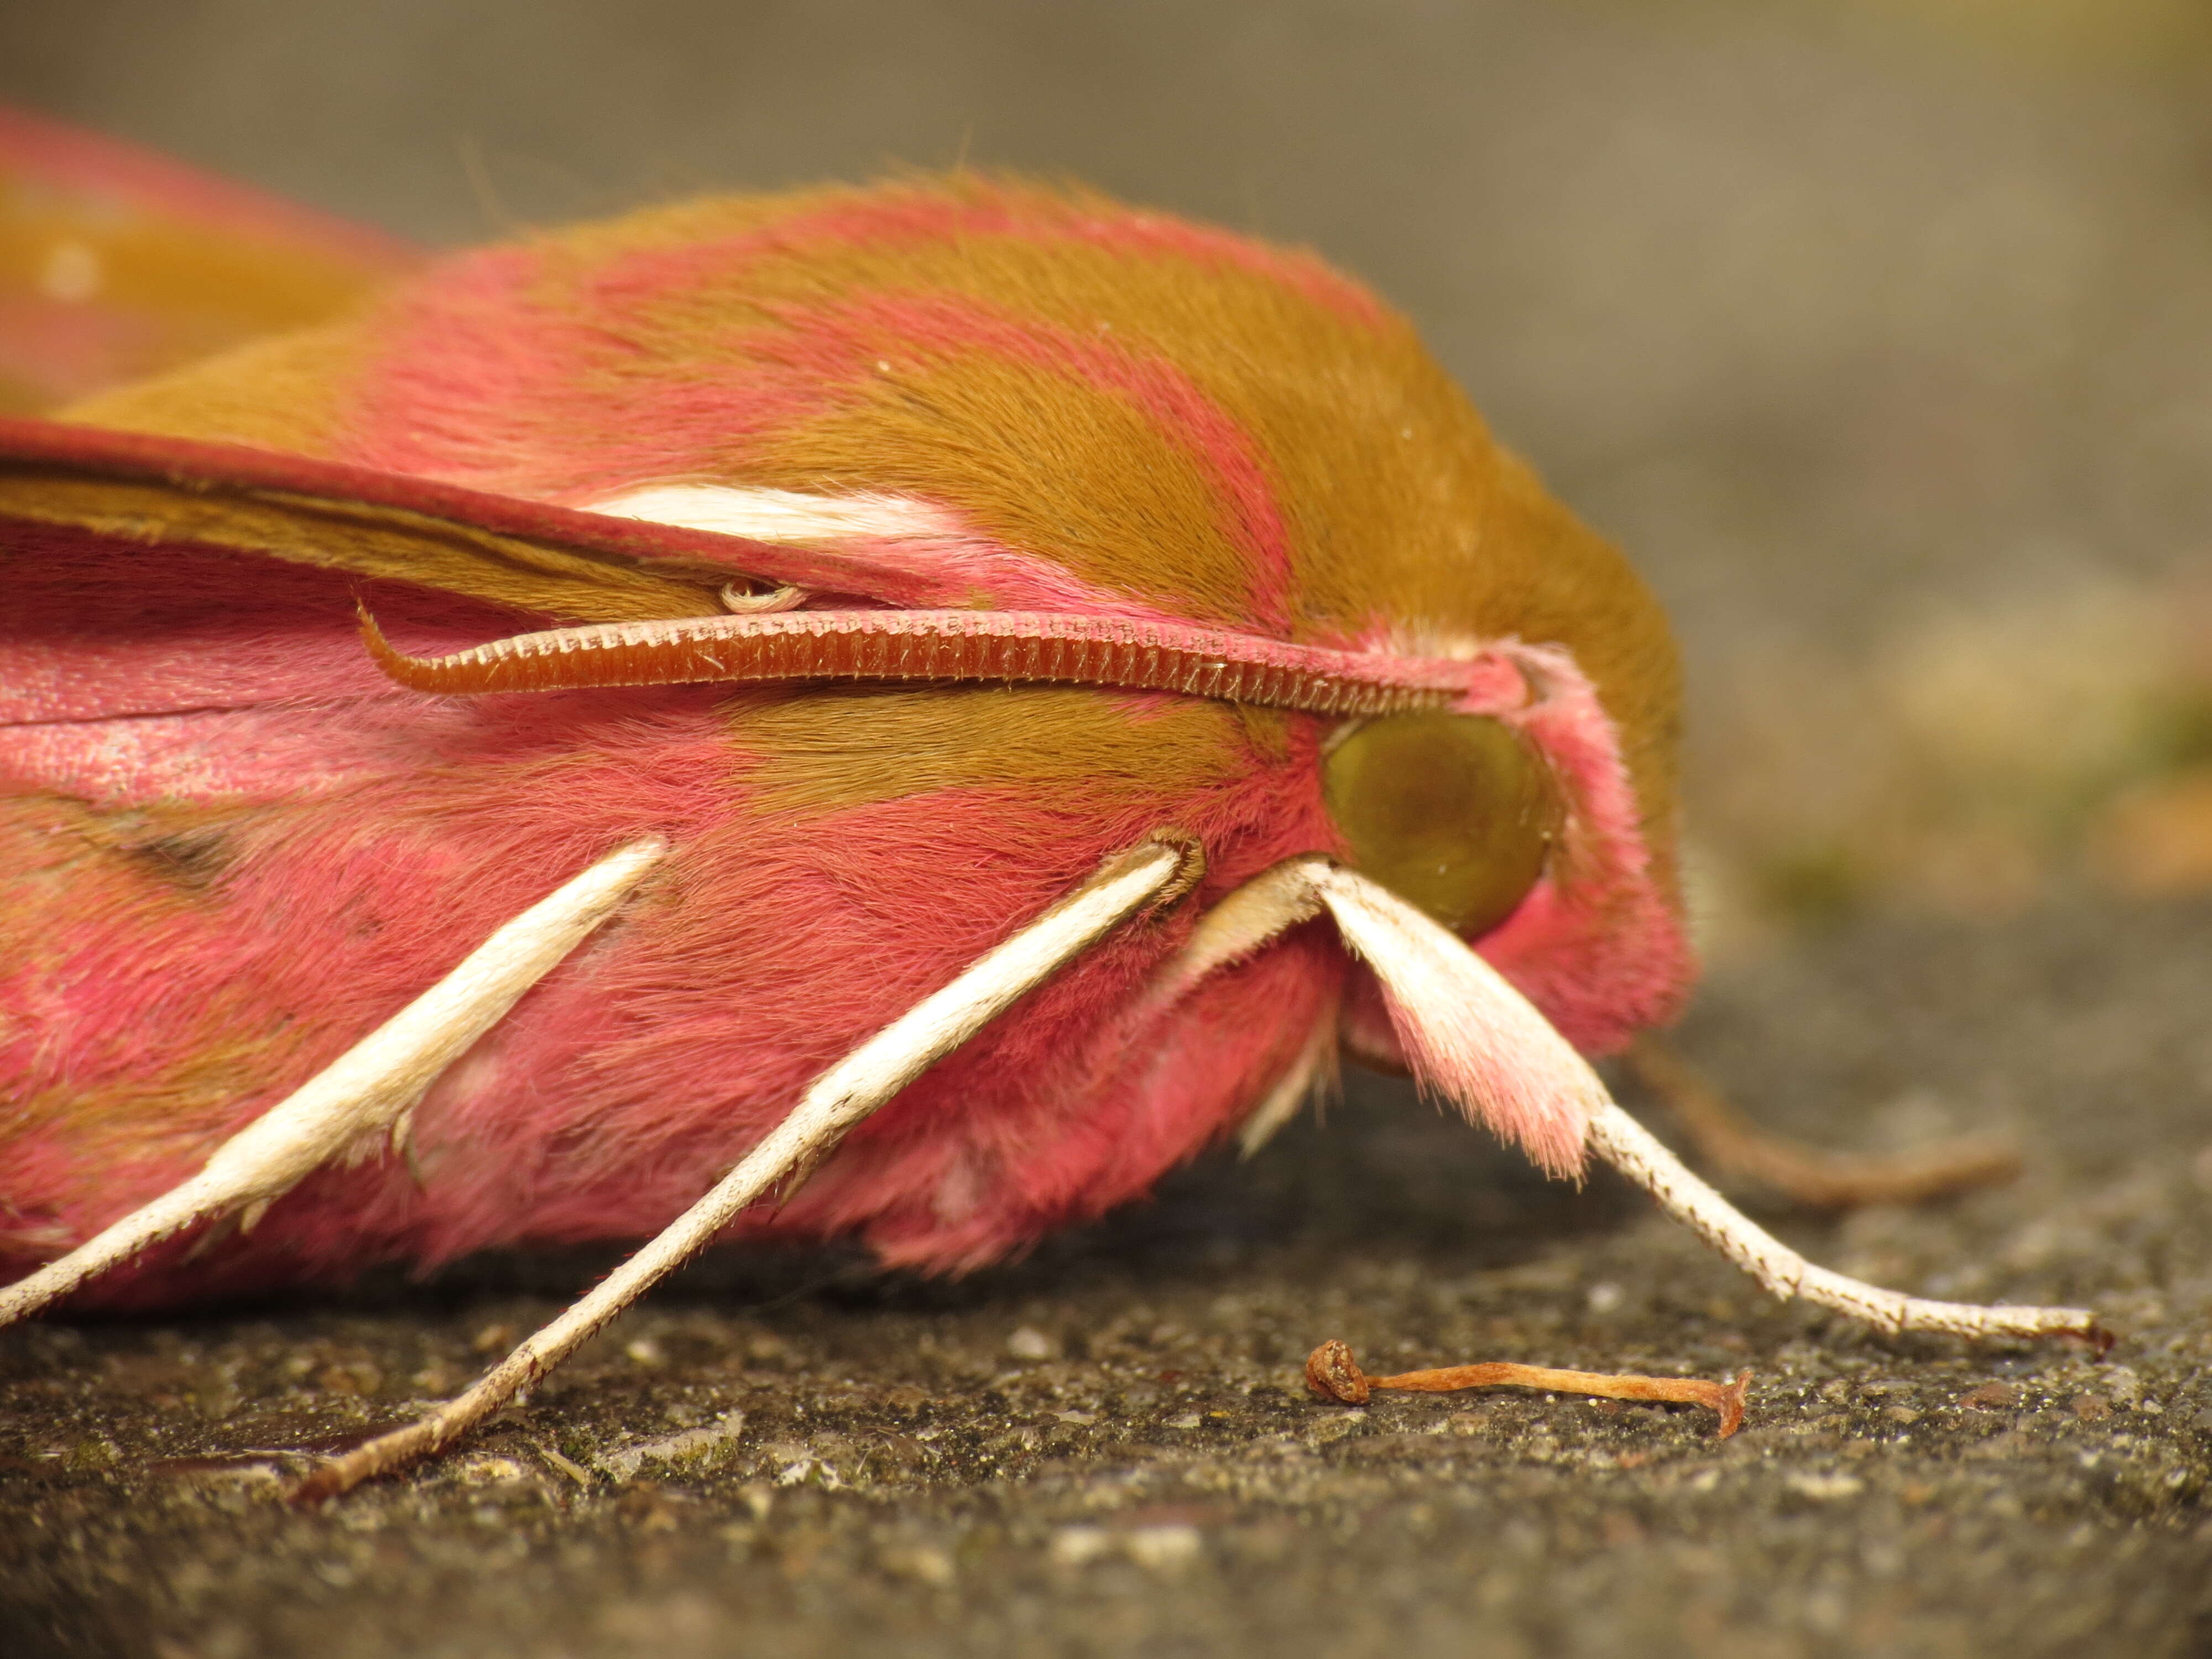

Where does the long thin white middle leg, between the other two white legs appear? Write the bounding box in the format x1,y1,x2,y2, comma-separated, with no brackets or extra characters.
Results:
294,841,1197,1504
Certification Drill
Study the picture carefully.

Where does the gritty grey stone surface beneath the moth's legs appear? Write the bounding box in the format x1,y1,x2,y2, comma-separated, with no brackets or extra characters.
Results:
13,902,2212,1659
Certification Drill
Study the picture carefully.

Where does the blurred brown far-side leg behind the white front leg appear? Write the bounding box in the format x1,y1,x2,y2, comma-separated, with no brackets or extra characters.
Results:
1628,1033,2020,1210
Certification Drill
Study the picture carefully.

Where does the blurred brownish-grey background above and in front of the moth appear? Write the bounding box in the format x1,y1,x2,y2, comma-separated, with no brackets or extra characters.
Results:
0,0,2212,964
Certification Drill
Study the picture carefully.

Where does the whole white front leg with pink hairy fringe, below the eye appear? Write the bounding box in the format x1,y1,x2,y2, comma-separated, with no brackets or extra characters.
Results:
1159,858,2104,1340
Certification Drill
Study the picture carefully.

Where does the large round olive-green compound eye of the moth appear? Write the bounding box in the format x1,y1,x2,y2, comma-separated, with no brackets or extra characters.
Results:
1321,714,1562,936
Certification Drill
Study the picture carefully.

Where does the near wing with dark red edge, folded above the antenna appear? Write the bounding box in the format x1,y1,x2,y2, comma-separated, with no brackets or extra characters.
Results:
0,418,867,726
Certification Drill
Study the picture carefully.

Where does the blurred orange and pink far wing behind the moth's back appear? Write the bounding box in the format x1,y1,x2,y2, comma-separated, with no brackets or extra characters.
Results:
0,108,420,414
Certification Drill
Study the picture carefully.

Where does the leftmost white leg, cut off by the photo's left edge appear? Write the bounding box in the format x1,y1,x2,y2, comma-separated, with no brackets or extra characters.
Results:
0,838,668,1325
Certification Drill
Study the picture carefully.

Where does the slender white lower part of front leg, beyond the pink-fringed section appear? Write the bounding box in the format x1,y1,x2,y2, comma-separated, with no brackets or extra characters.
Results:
1588,1099,2110,1343
